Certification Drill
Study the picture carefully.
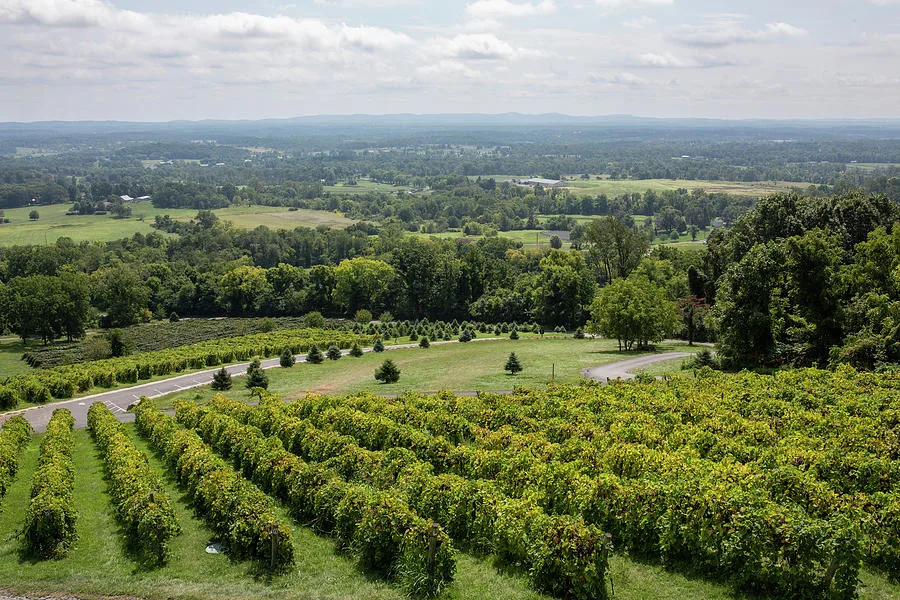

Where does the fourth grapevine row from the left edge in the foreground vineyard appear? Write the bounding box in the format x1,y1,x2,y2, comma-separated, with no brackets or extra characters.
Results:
135,400,294,569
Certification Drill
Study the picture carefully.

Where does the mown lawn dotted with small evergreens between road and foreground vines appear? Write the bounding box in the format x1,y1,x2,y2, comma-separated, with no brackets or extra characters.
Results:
151,336,687,407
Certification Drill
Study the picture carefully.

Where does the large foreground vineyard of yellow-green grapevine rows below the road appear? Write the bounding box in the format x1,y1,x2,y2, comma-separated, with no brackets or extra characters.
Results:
0,368,900,599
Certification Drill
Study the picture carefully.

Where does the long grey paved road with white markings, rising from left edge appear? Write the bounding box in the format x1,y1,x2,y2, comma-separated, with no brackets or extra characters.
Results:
0,338,500,432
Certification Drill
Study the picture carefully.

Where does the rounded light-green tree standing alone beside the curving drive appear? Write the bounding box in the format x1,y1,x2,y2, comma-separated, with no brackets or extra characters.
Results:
587,277,678,350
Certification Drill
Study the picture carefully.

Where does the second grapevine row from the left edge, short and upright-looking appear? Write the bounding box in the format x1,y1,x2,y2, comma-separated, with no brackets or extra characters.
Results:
23,408,78,558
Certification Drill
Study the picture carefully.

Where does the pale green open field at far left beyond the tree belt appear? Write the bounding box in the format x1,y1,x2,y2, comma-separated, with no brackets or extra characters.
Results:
0,202,353,246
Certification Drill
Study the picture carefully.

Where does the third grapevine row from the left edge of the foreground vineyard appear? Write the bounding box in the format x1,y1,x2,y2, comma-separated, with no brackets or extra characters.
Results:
88,402,181,563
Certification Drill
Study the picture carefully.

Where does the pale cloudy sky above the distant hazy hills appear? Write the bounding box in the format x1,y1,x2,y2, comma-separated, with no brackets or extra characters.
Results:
0,0,900,121
